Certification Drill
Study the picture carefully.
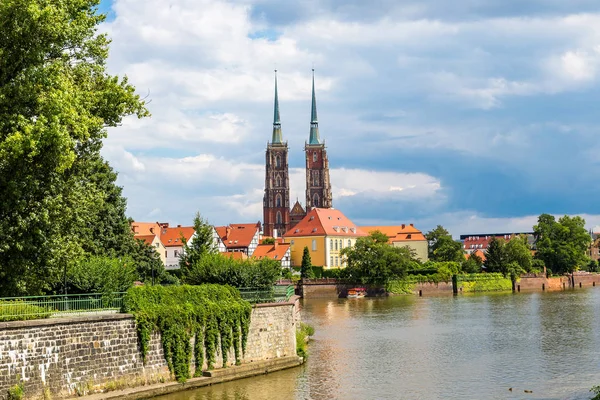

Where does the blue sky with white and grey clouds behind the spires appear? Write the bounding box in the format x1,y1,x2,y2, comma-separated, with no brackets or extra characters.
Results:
99,0,600,237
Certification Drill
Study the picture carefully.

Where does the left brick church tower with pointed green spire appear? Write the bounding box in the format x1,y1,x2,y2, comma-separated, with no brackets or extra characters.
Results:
263,70,290,237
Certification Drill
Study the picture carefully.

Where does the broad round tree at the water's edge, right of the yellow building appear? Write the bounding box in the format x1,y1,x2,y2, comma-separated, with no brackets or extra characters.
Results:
342,233,414,284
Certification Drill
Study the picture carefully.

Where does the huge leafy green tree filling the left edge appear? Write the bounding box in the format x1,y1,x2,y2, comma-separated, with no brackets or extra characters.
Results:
0,0,147,295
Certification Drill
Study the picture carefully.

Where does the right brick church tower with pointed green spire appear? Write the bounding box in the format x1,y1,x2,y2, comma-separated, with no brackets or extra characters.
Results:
304,69,332,212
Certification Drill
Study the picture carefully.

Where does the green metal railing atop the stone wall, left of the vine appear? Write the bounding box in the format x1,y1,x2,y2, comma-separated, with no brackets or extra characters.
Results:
0,292,125,322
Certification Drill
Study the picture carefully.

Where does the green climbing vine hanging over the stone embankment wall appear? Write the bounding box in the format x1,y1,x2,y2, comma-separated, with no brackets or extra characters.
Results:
123,284,252,382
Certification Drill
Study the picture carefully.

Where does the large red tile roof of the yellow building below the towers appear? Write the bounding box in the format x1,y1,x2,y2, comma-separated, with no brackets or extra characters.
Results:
283,208,367,238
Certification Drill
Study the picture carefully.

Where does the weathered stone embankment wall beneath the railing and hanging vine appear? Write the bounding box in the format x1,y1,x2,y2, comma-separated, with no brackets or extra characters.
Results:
0,298,299,399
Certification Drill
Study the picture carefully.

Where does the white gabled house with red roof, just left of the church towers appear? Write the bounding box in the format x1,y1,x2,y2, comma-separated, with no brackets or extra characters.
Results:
213,222,261,257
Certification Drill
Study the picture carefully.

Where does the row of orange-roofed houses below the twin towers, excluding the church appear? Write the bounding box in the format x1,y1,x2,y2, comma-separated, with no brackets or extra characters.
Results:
131,208,427,270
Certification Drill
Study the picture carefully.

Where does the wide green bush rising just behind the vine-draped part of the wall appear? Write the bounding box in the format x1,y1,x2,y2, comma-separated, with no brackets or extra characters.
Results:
182,253,281,289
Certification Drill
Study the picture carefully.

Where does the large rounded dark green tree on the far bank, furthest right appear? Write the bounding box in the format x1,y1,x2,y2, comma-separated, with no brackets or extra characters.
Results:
533,214,592,274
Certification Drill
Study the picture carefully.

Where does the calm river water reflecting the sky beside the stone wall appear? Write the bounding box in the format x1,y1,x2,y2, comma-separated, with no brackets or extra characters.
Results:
161,288,600,400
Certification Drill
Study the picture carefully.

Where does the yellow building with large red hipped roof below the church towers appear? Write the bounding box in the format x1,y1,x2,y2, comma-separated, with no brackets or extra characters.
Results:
283,208,367,269
